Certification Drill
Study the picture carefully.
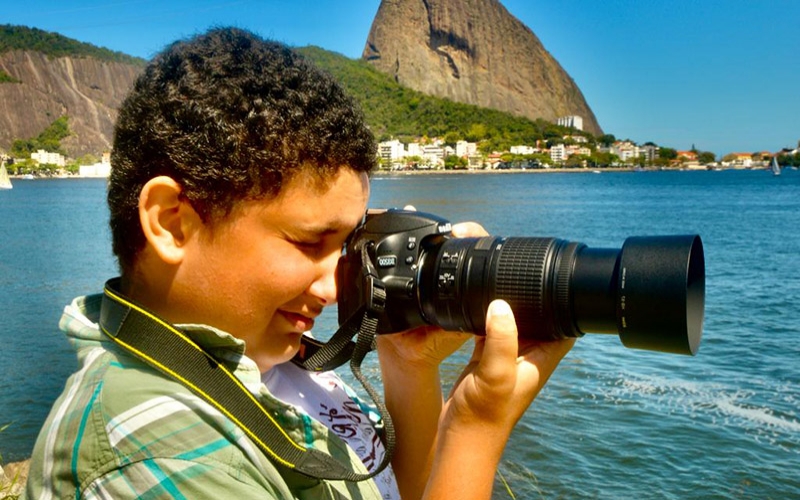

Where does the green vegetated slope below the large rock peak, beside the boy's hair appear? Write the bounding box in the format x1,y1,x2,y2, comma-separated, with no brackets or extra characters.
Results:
297,47,593,151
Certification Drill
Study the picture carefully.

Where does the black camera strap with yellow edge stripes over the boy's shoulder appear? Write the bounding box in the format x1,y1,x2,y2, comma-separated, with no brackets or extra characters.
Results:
100,278,394,481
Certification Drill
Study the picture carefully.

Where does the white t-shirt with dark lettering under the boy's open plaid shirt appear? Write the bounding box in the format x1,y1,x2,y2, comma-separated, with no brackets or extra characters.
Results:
261,363,400,500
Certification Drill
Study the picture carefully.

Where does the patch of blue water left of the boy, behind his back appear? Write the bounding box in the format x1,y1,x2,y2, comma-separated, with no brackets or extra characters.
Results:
0,179,116,461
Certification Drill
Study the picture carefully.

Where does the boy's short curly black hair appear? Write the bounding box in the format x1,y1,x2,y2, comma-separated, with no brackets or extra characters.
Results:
108,28,376,274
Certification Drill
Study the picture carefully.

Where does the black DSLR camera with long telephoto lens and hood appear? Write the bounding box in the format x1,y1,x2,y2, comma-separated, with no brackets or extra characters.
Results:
337,209,705,355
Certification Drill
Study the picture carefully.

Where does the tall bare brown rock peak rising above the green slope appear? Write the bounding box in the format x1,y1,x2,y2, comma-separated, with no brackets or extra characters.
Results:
363,0,602,135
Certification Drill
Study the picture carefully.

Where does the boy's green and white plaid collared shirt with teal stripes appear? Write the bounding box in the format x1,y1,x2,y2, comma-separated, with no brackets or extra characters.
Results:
23,295,382,500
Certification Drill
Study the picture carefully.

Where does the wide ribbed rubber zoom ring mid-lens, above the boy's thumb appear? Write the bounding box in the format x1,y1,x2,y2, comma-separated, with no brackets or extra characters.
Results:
495,238,554,334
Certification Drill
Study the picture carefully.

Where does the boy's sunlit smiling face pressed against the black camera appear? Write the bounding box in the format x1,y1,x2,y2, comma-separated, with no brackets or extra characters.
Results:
176,168,369,371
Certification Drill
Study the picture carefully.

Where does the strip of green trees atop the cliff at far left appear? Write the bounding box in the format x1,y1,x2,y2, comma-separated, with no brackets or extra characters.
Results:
0,24,146,66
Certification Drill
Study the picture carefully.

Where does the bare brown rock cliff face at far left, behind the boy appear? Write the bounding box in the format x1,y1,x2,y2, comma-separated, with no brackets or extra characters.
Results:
0,50,141,157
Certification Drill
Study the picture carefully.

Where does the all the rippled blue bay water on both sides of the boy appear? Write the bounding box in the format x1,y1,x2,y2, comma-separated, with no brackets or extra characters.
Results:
0,171,800,499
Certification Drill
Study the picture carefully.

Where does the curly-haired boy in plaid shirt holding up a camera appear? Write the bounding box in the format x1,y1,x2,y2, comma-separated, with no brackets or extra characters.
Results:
27,29,572,499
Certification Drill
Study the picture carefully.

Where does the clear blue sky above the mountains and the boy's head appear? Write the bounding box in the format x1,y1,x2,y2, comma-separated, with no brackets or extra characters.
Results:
0,0,800,157
